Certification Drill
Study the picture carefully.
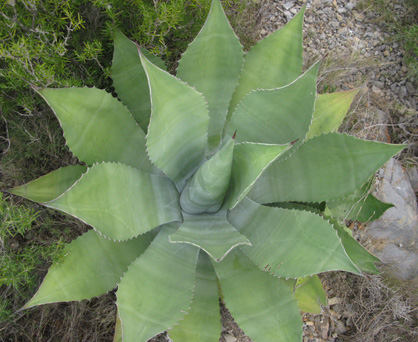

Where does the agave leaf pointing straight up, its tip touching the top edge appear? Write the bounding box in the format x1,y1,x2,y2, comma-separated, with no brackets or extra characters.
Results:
177,0,243,151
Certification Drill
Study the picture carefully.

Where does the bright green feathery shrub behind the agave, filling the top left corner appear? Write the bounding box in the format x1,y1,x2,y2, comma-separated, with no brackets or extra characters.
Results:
0,0,222,117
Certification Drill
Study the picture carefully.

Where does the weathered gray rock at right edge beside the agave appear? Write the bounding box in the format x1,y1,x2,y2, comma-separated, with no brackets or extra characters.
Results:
362,159,418,280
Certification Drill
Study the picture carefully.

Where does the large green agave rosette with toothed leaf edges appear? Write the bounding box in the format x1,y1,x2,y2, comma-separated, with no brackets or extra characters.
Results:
7,0,403,342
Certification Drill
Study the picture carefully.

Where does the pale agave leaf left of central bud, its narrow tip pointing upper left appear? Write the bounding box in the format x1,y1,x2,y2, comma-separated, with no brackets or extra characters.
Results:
141,54,209,189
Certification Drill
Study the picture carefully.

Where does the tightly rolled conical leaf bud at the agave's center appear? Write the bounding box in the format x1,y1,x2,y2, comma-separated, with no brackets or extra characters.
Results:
180,139,234,214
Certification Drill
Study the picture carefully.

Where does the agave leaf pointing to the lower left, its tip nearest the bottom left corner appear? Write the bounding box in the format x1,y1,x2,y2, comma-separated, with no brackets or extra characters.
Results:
25,230,155,308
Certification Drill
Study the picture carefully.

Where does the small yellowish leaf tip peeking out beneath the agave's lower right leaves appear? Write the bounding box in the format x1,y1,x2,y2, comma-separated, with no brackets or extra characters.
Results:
295,275,327,314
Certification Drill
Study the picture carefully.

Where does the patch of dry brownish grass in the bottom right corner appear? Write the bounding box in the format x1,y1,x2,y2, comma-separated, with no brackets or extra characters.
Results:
323,272,418,342
